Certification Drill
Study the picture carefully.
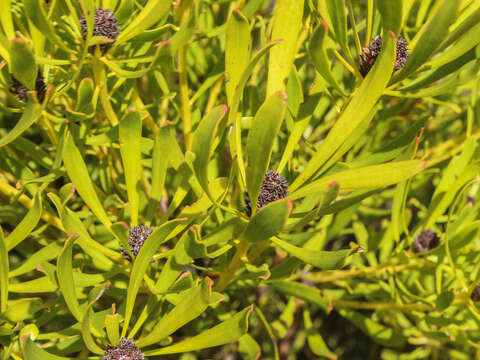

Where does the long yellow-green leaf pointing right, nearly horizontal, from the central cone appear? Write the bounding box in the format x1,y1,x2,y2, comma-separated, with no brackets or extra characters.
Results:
289,160,426,200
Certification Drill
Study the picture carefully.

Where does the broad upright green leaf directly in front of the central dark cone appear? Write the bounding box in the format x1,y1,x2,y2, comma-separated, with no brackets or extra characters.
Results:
246,91,287,214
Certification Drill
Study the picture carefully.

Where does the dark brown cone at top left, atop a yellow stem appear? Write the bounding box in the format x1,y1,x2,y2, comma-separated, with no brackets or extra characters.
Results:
80,8,120,54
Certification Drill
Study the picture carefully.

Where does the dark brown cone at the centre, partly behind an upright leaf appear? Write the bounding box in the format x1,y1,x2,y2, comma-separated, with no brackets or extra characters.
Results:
244,170,288,216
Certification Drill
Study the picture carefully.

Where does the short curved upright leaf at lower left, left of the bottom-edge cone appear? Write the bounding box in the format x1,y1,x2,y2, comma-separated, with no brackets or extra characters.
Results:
57,234,83,321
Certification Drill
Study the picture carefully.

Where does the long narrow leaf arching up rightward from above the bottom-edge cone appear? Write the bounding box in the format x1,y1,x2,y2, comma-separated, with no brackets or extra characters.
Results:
122,219,185,337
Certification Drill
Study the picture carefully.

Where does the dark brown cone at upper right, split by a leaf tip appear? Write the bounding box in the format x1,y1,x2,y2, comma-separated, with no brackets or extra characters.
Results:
360,35,409,77
